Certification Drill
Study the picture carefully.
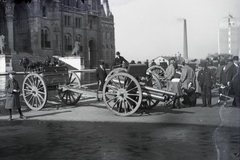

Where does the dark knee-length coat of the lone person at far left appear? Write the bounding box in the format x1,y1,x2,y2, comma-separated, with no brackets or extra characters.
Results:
5,78,21,109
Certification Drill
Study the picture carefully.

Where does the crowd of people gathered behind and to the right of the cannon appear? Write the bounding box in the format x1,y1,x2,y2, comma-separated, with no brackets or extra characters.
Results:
96,52,240,107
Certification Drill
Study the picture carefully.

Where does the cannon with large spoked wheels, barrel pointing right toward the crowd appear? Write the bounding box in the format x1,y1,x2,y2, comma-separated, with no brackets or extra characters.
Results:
103,64,176,116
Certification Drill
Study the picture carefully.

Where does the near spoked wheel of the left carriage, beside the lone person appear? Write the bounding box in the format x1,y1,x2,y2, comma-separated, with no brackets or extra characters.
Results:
22,73,48,110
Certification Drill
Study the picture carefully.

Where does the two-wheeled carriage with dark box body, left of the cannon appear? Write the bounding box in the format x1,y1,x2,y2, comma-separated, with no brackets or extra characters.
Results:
22,66,81,110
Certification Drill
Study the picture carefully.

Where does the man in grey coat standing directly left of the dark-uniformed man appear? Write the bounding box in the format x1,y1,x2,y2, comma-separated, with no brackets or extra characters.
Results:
180,60,196,106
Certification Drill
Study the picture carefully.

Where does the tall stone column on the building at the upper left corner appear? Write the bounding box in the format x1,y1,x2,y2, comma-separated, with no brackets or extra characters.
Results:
5,2,16,54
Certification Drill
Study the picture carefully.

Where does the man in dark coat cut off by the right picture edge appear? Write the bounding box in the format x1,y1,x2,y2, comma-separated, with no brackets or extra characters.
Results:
228,62,240,107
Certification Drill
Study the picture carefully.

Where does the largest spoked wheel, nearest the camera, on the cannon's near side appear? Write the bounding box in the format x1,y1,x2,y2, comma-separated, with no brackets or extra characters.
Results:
103,73,142,116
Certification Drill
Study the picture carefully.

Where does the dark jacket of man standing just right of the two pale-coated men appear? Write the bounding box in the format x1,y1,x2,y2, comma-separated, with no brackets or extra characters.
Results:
197,68,215,88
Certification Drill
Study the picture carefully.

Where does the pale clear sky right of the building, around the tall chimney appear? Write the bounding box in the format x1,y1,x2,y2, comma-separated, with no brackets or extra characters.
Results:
108,0,240,61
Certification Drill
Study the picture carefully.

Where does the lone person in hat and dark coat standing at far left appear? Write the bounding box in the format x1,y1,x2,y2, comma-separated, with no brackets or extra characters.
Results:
5,71,26,121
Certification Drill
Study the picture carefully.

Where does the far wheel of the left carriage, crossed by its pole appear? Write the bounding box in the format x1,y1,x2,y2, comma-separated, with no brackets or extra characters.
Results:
58,72,82,105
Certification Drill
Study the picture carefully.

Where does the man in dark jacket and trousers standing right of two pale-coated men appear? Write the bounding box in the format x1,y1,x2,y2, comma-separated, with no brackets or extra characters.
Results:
197,61,215,107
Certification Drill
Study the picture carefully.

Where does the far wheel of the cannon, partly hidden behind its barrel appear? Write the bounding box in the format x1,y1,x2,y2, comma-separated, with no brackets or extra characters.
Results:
141,74,162,109
